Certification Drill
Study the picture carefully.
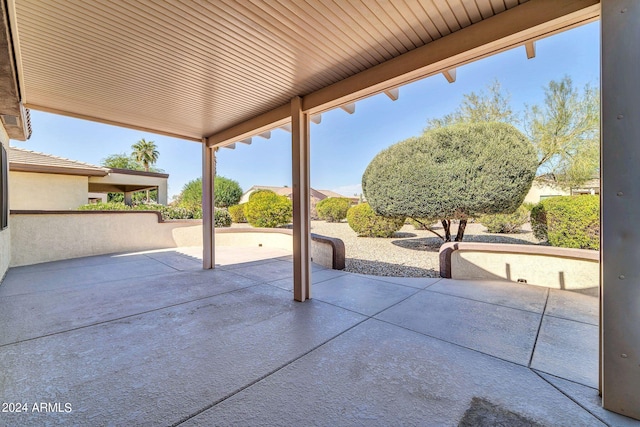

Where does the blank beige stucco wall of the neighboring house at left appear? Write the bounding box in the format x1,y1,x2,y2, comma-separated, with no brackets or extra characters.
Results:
9,172,89,210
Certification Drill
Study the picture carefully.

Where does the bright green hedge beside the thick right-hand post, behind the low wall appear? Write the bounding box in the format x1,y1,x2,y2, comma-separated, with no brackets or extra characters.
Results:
531,196,600,250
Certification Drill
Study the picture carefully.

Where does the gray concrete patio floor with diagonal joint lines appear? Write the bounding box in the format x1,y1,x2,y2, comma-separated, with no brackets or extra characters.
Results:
0,248,640,426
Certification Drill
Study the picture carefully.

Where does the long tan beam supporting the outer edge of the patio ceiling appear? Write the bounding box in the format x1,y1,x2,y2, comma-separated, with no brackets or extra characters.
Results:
207,0,600,146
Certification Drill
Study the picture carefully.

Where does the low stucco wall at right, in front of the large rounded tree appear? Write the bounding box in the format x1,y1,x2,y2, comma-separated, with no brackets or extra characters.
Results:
440,242,600,290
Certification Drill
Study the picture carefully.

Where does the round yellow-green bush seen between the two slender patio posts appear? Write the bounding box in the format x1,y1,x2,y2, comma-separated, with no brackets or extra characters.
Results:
244,191,293,228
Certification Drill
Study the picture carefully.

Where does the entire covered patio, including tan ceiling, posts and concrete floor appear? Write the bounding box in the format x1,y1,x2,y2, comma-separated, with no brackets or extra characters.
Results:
0,0,640,425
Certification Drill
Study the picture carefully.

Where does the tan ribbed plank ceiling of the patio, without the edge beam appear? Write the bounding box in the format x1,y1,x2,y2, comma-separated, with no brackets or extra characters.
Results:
9,0,584,140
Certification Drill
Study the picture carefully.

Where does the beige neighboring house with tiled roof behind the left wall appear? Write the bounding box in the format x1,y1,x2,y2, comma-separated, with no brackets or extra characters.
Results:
7,147,169,210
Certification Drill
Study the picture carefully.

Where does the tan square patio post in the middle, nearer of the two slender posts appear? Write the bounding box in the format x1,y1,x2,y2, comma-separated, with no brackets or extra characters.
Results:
291,96,311,301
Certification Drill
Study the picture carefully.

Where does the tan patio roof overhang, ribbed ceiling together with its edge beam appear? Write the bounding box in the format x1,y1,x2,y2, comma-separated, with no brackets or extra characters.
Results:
7,0,600,145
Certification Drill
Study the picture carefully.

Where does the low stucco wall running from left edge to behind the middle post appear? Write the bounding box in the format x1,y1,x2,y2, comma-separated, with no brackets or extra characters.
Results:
10,211,345,270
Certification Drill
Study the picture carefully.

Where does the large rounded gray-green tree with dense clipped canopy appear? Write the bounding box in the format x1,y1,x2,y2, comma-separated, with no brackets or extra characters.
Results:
362,122,538,241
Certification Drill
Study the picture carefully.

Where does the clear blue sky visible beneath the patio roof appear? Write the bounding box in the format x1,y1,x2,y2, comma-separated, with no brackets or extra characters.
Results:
12,22,600,198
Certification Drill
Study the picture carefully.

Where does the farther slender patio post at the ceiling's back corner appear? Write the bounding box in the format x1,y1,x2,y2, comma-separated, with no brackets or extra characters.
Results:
202,138,216,270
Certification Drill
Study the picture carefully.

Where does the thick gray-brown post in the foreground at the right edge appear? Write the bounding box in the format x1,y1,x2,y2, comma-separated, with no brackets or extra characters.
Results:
600,0,640,419
